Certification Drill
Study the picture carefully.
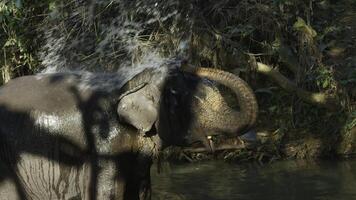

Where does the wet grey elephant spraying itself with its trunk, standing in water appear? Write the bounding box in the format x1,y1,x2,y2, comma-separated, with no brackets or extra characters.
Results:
0,63,258,200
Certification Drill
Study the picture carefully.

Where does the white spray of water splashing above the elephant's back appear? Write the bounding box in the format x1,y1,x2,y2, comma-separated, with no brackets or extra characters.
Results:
39,0,189,77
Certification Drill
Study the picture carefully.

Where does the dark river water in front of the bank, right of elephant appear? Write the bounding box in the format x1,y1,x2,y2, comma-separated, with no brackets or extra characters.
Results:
152,161,356,200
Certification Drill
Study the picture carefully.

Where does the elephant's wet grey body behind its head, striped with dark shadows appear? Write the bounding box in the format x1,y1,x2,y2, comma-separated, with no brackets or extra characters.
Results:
0,74,159,200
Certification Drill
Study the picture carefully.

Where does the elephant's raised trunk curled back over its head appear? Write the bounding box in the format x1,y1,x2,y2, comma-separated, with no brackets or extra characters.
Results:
183,66,258,134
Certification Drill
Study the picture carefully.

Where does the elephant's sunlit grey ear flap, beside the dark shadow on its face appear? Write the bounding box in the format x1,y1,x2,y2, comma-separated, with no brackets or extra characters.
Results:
117,84,159,132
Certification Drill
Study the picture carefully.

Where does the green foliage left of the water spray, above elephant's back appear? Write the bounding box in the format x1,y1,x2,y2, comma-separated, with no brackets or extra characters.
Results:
0,0,52,83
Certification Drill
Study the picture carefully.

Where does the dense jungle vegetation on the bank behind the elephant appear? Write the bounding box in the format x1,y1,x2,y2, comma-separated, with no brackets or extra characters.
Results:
0,0,356,161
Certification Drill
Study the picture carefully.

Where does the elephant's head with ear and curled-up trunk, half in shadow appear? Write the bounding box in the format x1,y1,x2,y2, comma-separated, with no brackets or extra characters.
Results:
118,62,258,150
